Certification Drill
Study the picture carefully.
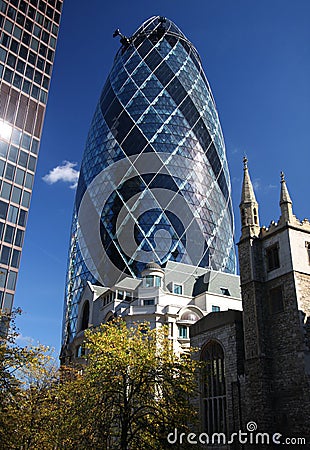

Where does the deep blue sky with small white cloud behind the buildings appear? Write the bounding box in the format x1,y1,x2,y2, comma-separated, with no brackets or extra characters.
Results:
15,0,310,353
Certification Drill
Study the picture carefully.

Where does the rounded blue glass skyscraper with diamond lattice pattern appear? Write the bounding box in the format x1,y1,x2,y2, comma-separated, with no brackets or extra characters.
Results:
64,17,235,342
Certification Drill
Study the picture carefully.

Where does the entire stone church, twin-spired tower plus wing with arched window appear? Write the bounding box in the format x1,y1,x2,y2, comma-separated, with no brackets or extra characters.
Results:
190,158,310,448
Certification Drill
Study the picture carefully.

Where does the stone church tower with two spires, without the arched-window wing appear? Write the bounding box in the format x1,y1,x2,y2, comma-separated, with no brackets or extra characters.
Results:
238,158,310,442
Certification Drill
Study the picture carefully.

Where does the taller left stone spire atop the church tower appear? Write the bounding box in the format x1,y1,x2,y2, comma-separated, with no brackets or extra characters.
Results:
239,157,260,236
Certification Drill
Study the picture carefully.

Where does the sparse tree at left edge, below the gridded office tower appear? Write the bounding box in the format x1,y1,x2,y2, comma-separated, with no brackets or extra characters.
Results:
0,309,57,450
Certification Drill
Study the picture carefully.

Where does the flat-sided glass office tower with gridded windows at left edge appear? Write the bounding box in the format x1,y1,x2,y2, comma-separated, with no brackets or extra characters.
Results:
0,0,63,311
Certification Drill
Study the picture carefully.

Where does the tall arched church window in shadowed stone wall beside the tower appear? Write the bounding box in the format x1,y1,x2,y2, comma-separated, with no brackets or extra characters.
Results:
201,341,226,435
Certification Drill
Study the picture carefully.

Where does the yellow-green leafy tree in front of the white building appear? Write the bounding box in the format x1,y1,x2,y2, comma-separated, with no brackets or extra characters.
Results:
72,320,199,450
